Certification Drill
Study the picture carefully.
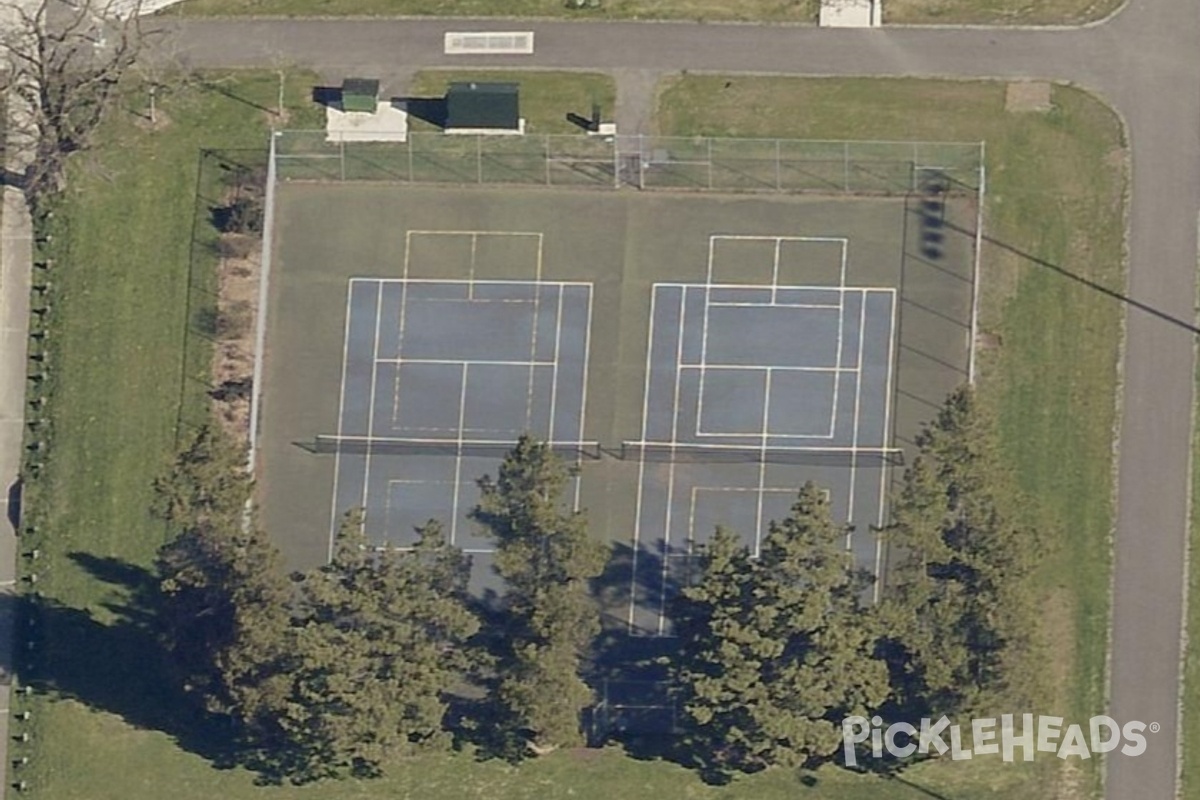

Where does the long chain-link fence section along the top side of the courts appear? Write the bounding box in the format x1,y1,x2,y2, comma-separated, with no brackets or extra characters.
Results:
276,131,983,196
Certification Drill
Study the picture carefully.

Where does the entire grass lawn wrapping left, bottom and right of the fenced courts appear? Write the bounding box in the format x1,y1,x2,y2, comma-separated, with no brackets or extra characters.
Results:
11,73,1123,800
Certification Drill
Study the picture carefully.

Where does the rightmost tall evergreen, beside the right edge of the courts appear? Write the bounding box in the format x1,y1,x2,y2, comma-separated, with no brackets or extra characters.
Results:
883,387,1040,714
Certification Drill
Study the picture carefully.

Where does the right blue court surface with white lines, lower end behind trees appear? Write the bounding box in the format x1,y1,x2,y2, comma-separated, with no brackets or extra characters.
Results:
624,283,896,634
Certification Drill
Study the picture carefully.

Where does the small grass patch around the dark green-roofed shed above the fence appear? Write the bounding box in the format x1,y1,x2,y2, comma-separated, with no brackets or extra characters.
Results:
408,70,617,133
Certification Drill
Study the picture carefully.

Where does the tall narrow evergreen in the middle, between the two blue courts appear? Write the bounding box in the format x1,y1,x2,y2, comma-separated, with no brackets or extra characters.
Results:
473,437,608,752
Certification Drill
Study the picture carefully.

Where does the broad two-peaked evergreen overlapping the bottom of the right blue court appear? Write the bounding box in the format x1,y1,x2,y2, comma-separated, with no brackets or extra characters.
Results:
674,483,888,770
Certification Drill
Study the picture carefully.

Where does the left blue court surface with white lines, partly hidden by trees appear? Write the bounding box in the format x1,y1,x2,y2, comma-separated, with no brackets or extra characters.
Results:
320,278,592,592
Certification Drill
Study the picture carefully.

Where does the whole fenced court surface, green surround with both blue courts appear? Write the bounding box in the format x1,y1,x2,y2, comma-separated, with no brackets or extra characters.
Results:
259,181,976,633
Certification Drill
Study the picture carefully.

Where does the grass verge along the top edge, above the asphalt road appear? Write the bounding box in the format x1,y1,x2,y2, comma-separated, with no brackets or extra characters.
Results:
168,0,1121,25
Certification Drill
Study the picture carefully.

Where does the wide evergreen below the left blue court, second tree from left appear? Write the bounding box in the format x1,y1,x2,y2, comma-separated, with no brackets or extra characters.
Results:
270,515,479,778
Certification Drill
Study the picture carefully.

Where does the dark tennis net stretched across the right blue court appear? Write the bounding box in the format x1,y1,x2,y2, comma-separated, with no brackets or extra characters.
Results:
620,441,904,467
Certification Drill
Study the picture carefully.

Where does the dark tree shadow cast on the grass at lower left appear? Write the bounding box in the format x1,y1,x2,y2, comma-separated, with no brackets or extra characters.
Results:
21,552,245,769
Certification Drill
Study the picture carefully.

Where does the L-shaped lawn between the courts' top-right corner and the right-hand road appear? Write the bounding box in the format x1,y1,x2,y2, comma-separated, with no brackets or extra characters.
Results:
659,77,1127,789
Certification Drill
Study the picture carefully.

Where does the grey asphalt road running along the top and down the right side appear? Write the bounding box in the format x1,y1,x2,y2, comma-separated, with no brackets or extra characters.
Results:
158,0,1200,800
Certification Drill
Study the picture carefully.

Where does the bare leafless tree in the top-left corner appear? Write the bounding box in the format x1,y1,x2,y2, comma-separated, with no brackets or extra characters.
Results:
0,0,143,207
